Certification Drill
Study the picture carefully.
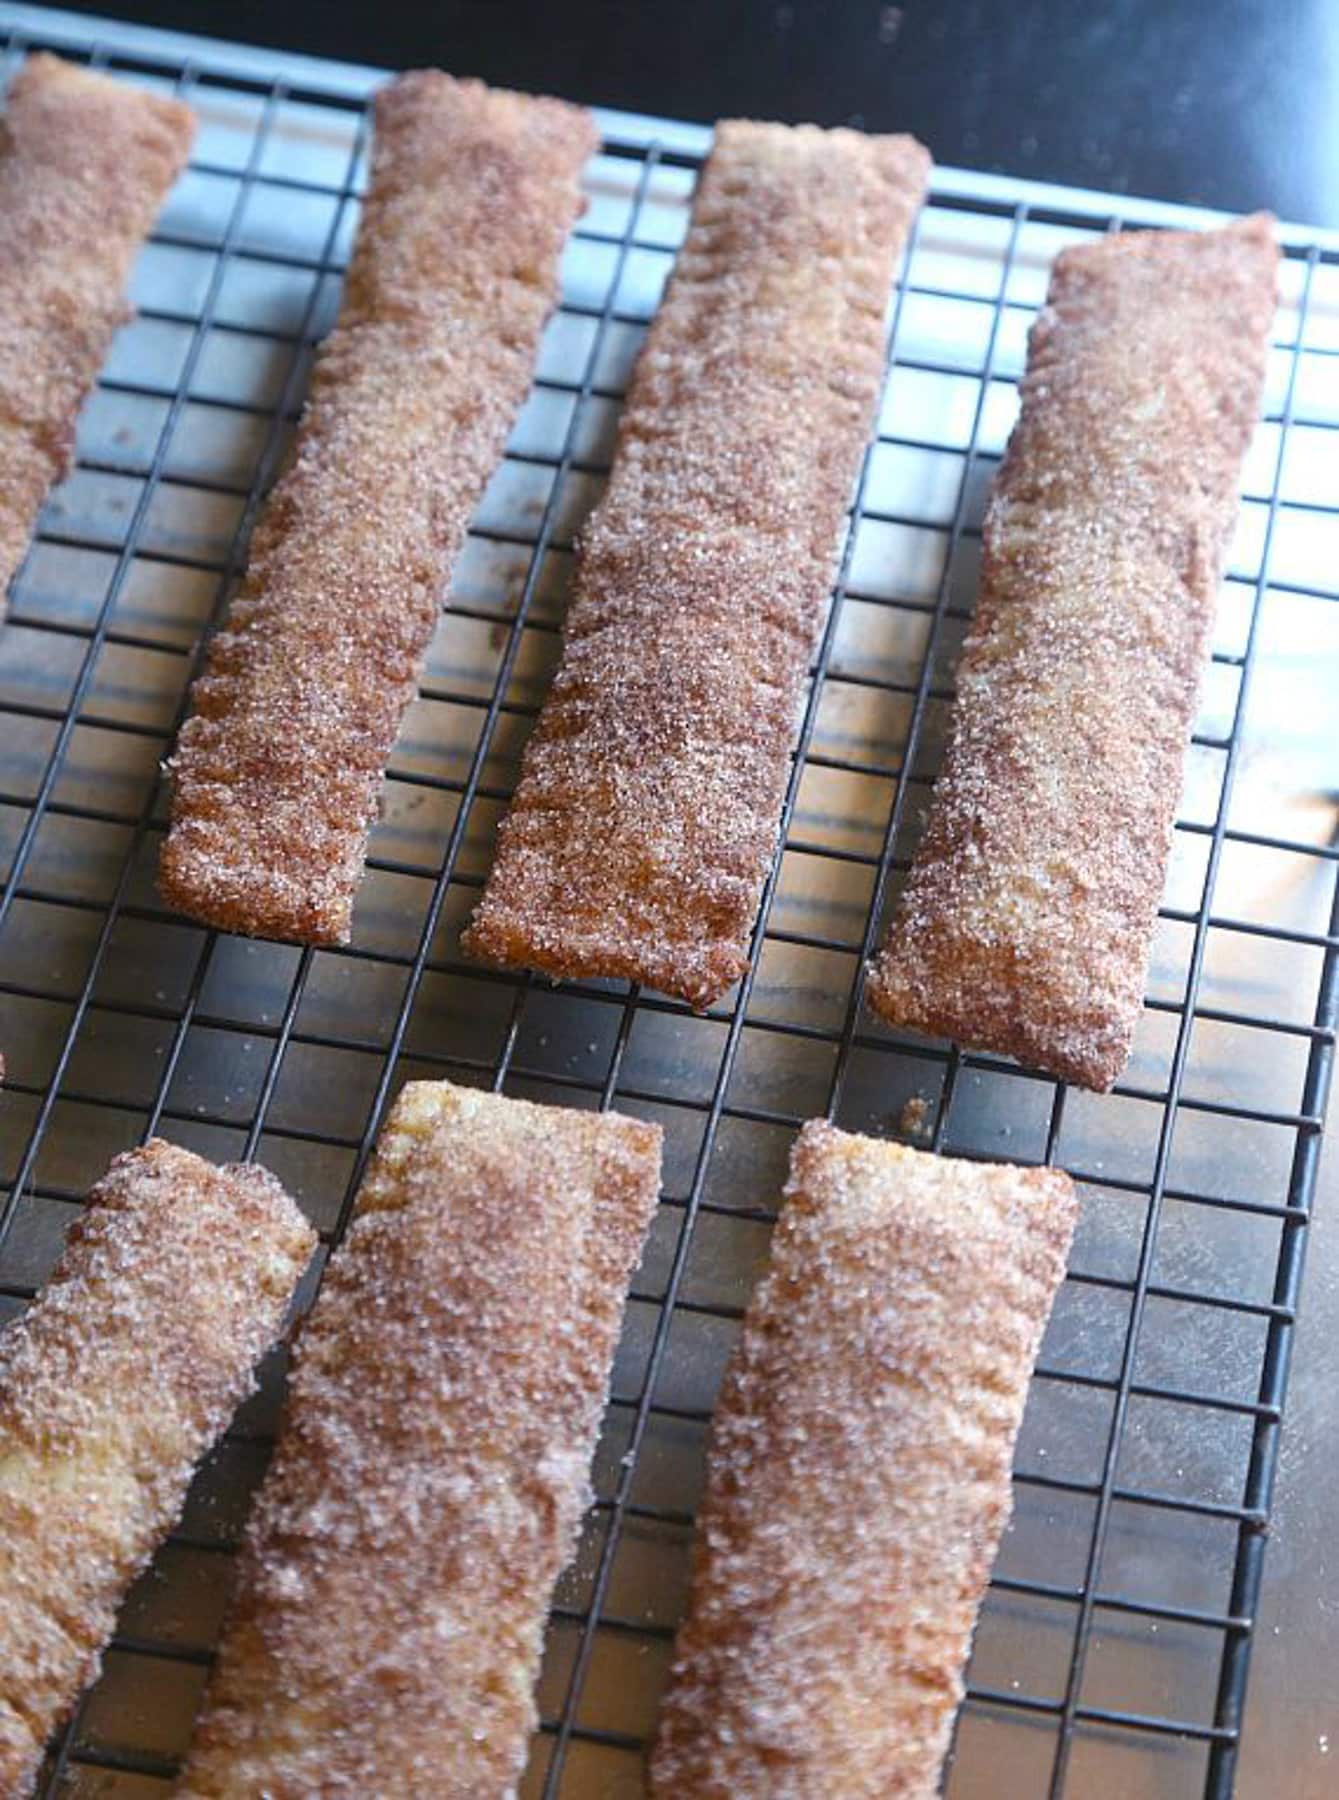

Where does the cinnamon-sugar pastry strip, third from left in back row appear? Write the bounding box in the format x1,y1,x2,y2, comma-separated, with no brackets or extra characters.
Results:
464,121,929,1008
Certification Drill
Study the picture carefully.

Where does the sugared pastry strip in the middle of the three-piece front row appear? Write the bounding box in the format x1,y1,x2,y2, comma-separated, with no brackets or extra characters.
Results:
180,1082,661,1800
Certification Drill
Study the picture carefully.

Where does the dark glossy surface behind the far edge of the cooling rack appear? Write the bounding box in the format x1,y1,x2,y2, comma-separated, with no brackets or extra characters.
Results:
49,0,1339,225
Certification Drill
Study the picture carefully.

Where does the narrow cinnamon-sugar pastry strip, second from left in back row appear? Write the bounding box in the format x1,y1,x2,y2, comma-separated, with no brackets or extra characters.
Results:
158,70,596,943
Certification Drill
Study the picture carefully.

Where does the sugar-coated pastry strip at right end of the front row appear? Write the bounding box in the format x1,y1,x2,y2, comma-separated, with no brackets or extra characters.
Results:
652,1123,1074,1800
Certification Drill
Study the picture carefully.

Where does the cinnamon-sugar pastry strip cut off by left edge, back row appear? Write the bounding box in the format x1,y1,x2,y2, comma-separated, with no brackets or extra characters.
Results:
0,54,194,607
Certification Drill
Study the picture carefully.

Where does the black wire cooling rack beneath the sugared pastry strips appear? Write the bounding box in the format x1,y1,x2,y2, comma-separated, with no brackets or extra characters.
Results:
0,14,1339,1796
